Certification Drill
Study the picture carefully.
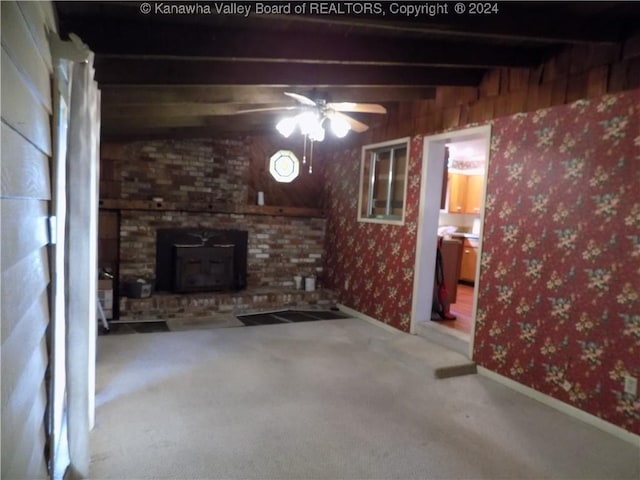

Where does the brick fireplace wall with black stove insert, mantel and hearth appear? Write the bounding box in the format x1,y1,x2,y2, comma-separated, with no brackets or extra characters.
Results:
100,139,334,320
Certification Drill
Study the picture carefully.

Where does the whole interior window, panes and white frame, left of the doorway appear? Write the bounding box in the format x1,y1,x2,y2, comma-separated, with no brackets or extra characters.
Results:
358,138,409,225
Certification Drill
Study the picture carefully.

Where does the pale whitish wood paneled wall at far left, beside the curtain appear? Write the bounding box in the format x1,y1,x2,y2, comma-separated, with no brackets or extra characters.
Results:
0,1,55,479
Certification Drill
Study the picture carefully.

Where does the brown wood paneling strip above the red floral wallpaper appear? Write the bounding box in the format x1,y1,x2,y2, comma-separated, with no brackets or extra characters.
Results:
360,37,640,144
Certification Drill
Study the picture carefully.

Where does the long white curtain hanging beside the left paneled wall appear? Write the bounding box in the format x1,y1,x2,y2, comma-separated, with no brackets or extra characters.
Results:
65,50,100,478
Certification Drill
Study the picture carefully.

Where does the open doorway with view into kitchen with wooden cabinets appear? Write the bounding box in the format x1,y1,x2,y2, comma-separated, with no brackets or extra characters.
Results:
410,125,491,358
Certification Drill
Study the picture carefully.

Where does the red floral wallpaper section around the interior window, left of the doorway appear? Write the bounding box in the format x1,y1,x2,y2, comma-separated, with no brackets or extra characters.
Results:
325,137,422,332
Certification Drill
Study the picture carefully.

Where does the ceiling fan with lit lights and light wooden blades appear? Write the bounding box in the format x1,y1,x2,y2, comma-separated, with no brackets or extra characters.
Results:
236,92,387,142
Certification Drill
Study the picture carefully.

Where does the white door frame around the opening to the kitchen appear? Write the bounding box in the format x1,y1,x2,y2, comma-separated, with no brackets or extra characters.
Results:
409,124,491,358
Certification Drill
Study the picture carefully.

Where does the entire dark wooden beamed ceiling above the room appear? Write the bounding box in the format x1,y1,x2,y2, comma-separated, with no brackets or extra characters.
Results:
55,1,640,138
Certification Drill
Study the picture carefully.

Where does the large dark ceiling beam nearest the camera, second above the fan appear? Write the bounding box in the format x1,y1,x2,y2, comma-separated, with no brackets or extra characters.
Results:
56,19,550,68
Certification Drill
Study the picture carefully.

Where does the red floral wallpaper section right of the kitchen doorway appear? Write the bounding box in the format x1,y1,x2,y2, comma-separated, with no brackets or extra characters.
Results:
474,90,640,433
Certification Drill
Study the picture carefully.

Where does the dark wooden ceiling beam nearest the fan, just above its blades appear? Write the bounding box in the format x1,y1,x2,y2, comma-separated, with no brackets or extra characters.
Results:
94,55,483,88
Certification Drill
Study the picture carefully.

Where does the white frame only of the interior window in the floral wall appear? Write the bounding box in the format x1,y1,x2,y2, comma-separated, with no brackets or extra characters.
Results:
358,137,411,225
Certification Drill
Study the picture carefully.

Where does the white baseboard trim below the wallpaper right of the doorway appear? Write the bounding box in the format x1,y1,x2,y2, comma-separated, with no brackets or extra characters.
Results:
478,366,640,448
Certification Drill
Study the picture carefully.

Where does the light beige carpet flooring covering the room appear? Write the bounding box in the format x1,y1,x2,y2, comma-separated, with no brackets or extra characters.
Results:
90,318,640,480
